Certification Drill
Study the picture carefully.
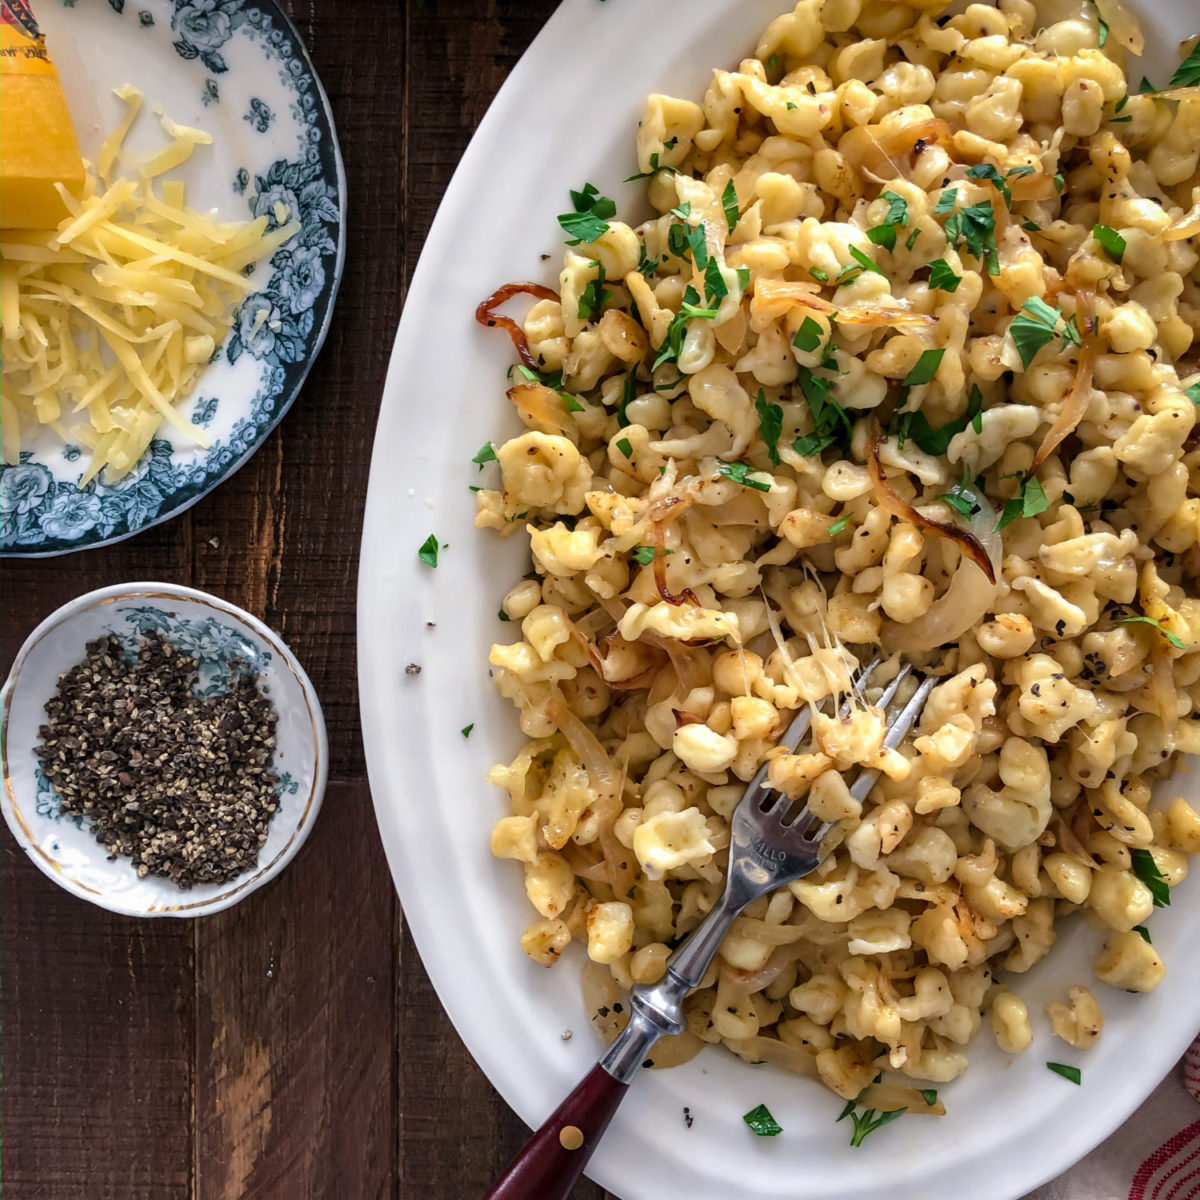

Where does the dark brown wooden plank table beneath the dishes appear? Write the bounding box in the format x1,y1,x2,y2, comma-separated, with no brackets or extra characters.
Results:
0,0,602,1200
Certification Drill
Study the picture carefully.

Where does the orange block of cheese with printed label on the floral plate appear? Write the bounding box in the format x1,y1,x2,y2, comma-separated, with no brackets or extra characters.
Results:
0,0,84,229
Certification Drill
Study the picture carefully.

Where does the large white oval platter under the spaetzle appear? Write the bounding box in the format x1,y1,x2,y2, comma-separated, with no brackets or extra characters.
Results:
359,0,1200,1200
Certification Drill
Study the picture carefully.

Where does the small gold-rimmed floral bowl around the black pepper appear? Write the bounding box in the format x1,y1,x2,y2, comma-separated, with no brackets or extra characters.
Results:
0,583,329,917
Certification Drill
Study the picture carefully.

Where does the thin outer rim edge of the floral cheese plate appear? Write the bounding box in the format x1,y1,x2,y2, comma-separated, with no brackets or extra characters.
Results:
0,0,348,558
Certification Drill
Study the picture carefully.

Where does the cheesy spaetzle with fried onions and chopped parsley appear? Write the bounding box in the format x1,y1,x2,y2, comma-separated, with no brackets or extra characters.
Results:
475,0,1200,1098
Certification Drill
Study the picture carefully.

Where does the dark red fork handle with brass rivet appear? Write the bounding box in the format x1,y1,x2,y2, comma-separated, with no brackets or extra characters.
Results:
484,1063,629,1200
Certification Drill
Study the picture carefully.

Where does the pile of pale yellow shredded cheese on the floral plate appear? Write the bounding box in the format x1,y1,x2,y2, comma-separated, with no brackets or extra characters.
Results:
0,85,300,484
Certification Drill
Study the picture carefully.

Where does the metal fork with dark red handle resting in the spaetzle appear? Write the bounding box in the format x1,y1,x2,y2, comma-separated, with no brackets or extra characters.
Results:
485,659,937,1200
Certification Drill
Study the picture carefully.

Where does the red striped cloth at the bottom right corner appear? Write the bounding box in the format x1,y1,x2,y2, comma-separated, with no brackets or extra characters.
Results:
1025,1037,1200,1200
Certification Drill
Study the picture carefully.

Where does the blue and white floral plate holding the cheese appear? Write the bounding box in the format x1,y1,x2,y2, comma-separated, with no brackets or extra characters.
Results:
0,0,346,556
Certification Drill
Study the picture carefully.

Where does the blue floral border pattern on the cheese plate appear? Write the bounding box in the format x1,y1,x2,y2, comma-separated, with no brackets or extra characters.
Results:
0,0,344,554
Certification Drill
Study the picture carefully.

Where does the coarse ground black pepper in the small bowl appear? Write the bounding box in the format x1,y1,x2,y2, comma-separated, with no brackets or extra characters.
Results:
36,631,280,888
